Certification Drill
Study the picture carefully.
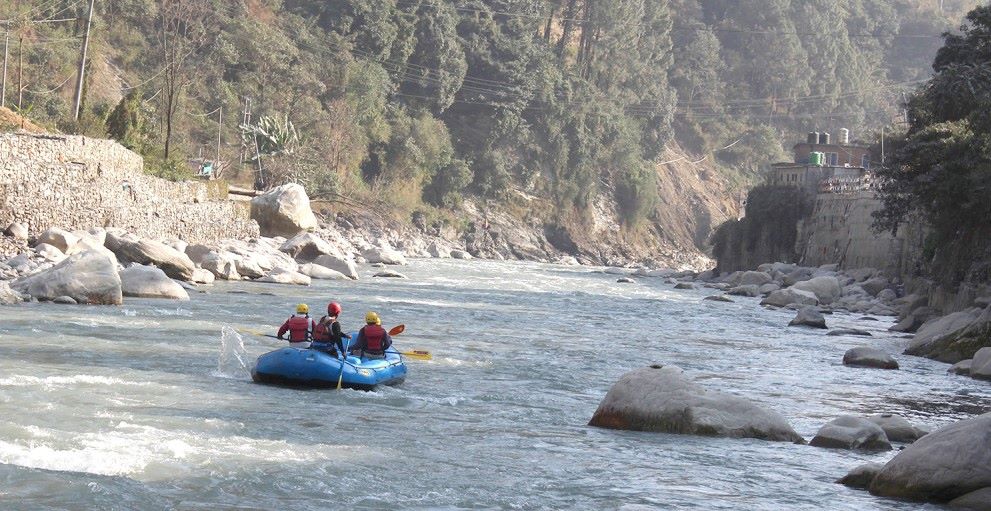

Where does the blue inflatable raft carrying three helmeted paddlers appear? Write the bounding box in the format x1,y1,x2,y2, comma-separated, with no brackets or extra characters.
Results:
251,340,406,390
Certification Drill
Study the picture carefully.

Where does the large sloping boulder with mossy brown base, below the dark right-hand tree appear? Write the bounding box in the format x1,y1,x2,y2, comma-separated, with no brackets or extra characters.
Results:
905,307,991,364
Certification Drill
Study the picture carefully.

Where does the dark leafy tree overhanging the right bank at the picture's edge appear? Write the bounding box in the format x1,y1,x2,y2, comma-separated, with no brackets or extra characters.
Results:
877,6,991,285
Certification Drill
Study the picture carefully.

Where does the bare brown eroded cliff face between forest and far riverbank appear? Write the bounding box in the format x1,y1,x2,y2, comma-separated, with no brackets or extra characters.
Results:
324,144,739,270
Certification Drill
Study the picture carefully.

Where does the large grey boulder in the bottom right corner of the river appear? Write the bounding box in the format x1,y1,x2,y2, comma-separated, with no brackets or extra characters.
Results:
870,413,991,502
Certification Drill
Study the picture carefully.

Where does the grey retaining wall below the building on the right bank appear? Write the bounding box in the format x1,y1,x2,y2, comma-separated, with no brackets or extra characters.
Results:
796,191,923,276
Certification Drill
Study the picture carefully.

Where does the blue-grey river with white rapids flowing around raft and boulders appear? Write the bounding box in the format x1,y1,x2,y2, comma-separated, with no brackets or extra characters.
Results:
0,260,991,511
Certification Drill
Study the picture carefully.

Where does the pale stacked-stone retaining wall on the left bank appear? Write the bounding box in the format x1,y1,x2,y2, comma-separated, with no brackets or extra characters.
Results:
0,133,258,247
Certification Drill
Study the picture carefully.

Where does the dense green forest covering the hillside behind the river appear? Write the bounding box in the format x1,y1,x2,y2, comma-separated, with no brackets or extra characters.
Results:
0,0,973,225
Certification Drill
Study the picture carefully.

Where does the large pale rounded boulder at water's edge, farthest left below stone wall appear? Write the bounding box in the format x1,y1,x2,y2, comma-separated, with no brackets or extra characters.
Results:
11,250,123,305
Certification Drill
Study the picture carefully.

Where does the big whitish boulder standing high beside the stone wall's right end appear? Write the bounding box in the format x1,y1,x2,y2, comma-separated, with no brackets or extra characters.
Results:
251,183,317,238
